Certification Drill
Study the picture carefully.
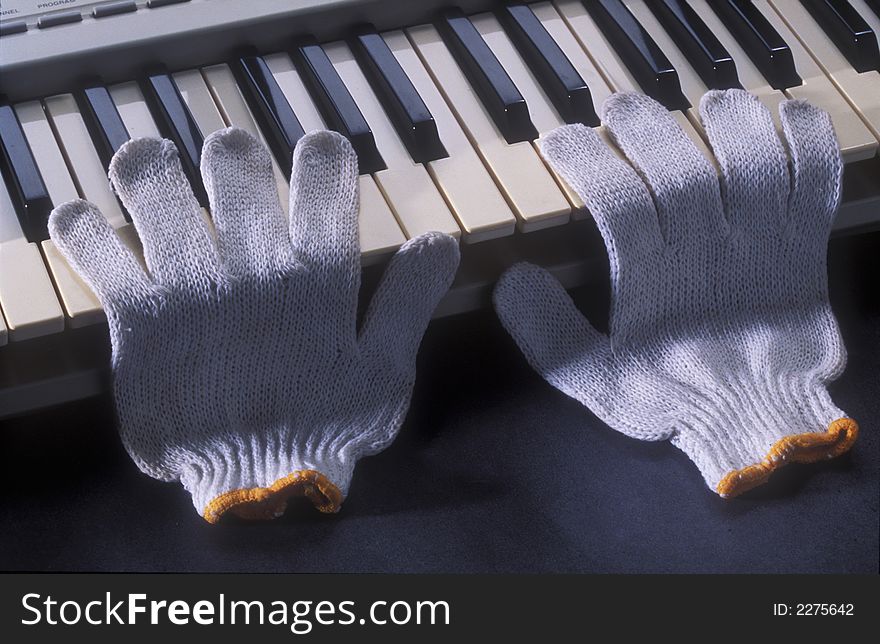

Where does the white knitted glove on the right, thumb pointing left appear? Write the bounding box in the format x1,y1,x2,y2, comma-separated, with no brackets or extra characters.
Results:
494,90,858,497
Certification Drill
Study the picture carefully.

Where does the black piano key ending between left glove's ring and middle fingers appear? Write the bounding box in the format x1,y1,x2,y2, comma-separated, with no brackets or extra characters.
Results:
142,72,208,207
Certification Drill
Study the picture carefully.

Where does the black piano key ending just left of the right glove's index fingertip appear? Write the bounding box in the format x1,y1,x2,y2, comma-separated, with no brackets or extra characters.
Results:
437,9,538,143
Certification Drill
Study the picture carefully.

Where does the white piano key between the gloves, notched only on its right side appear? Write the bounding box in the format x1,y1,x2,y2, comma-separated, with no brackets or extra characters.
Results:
407,25,571,232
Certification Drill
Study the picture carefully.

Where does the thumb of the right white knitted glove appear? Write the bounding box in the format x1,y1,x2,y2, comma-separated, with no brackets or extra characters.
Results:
492,262,612,408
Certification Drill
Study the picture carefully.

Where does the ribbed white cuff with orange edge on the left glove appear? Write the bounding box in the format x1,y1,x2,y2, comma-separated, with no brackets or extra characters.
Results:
180,441,353,523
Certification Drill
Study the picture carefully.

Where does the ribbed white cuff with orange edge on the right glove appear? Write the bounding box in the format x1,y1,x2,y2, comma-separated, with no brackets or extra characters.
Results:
672,382,858,497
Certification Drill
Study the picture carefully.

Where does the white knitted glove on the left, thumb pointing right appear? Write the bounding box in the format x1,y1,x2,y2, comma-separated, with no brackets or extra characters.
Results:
49,128,459,523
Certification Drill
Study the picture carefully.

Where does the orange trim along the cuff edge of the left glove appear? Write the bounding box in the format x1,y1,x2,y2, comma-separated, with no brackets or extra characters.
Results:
203,470,342,523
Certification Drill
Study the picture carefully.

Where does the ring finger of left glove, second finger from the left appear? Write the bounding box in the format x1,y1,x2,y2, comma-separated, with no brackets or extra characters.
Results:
109,139,220,286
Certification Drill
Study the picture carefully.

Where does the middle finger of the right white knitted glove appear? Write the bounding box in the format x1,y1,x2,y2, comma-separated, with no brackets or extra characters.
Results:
602,92,727,244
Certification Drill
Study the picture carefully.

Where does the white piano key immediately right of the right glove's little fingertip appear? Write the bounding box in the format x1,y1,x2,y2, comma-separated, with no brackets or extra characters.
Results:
754,0,880,163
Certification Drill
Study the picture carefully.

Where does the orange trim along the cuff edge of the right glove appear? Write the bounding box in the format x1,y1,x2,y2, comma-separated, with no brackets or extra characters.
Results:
715,418,859,498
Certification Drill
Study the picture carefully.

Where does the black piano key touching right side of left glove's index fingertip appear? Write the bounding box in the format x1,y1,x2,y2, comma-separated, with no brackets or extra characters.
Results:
294,44,387,174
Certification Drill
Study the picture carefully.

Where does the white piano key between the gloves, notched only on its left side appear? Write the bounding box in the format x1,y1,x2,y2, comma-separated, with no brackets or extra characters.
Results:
382,31,516,242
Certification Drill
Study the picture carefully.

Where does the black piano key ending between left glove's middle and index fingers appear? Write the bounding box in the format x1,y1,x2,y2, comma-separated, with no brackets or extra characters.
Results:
234,56,305,176
